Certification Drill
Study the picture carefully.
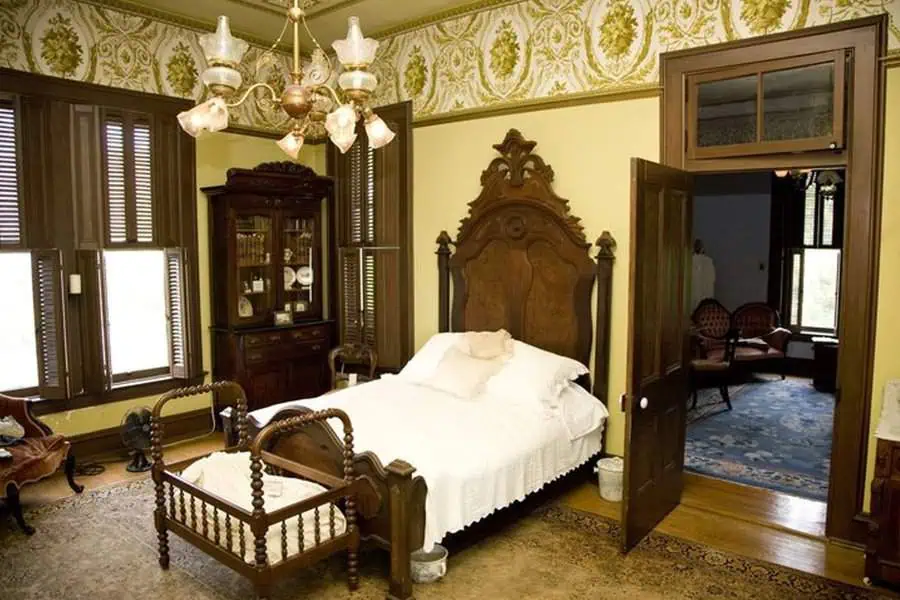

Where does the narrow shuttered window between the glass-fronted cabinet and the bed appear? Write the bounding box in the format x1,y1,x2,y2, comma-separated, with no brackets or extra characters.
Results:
329,102,413,370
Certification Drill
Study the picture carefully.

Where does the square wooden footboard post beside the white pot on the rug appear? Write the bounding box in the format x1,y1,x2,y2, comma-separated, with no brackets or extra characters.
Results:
386,460,415,600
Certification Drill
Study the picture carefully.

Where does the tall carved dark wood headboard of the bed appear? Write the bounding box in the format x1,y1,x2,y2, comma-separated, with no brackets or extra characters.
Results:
437,129,615,401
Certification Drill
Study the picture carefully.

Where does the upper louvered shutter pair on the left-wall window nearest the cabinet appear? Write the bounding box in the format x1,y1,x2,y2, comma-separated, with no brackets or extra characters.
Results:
102,112,156,246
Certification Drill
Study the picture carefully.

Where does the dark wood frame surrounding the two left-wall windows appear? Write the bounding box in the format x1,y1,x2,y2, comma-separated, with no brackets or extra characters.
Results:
0,68,205,414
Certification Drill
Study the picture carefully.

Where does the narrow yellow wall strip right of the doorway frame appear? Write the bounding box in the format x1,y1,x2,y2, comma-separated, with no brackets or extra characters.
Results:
866,68,900,507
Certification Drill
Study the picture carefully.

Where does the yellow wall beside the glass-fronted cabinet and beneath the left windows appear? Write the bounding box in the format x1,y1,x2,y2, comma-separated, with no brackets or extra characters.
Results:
42,133,326,435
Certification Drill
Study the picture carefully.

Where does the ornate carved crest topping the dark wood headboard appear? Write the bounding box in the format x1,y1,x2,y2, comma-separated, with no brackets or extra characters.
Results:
457,129,590,247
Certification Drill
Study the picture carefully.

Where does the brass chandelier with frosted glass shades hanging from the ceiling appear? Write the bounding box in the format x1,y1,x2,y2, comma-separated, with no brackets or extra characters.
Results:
178,0,395,159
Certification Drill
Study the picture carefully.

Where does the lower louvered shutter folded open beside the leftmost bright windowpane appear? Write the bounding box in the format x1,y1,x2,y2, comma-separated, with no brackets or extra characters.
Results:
31,249,68,400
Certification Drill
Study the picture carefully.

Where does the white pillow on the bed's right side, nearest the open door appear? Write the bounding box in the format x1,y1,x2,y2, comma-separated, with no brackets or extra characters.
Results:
485,340,589,408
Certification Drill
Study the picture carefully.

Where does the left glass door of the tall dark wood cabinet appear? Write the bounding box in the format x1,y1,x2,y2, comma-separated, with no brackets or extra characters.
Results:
234,212,275,323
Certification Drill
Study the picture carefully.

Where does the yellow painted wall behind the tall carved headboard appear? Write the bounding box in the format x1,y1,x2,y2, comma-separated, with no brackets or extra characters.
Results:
413,98,659,454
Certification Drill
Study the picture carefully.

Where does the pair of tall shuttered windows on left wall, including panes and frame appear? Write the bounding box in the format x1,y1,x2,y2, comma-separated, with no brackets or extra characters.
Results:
0,74,200,411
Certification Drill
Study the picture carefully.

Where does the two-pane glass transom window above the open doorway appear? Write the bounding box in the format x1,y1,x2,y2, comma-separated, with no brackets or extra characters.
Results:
687,51,846,159
